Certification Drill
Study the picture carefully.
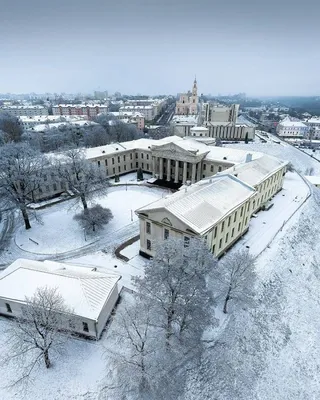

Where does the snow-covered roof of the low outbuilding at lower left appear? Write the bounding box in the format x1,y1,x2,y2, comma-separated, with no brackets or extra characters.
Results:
0,259,120,320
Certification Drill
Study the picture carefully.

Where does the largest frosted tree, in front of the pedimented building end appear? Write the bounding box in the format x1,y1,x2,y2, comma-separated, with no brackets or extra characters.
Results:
134,238,216,345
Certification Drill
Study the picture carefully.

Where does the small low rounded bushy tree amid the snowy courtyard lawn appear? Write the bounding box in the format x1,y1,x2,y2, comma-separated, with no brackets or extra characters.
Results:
73,204,113,232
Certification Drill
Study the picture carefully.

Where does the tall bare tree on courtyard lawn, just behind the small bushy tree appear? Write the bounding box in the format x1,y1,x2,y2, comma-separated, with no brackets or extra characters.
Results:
56,149,109,209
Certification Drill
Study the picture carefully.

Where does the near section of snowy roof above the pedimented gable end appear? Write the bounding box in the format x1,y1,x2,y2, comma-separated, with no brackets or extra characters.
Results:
136,174,256,234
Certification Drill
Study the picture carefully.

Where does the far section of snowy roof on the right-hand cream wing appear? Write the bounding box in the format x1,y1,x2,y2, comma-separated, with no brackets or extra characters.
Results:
224,155,288,186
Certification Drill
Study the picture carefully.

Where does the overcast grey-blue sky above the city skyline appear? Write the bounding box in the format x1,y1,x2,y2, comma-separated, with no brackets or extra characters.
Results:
0,0,320,95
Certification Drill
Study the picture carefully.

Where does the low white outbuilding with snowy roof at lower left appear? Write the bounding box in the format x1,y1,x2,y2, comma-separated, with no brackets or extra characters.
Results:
0,259,120,339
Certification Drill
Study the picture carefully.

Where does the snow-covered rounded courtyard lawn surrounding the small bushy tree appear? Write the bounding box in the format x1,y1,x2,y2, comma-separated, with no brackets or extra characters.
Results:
15,186,168,254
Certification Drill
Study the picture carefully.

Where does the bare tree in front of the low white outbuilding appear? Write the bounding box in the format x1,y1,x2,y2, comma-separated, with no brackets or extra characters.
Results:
5,287,72,383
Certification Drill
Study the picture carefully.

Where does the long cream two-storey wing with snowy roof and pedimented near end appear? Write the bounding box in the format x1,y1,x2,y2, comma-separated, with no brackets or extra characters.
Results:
136,155,287,257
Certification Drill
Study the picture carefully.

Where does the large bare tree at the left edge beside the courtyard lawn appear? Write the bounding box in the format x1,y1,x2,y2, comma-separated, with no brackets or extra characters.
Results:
0,143,47,229
